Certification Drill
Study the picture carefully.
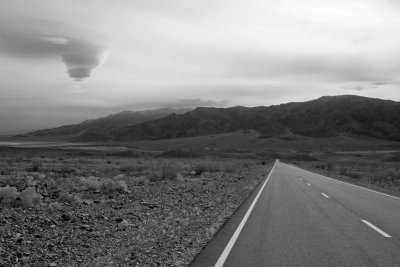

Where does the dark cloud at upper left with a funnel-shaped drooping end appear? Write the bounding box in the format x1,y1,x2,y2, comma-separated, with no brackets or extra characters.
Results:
0,16,105,80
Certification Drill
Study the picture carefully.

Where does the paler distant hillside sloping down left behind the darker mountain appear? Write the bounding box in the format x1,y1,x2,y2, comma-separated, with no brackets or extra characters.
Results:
22,108,191,141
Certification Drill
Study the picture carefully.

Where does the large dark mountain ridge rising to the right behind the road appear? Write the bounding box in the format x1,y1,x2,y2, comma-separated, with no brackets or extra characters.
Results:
112,95,400,141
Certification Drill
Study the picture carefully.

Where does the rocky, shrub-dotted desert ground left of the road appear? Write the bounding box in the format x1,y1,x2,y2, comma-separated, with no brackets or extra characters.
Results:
0,148,271,266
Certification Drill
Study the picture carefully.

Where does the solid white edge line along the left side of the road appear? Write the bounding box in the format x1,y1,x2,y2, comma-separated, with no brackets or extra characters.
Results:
214,161,276,267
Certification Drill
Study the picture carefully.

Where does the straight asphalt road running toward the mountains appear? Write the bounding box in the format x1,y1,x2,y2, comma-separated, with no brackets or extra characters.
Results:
192,162,400,266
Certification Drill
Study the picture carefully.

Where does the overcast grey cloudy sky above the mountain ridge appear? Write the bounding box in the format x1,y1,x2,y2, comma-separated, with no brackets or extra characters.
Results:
0,0,400,131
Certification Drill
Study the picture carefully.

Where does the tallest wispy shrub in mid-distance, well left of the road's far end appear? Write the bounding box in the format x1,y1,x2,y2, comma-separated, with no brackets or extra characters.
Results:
147,161,182,182
